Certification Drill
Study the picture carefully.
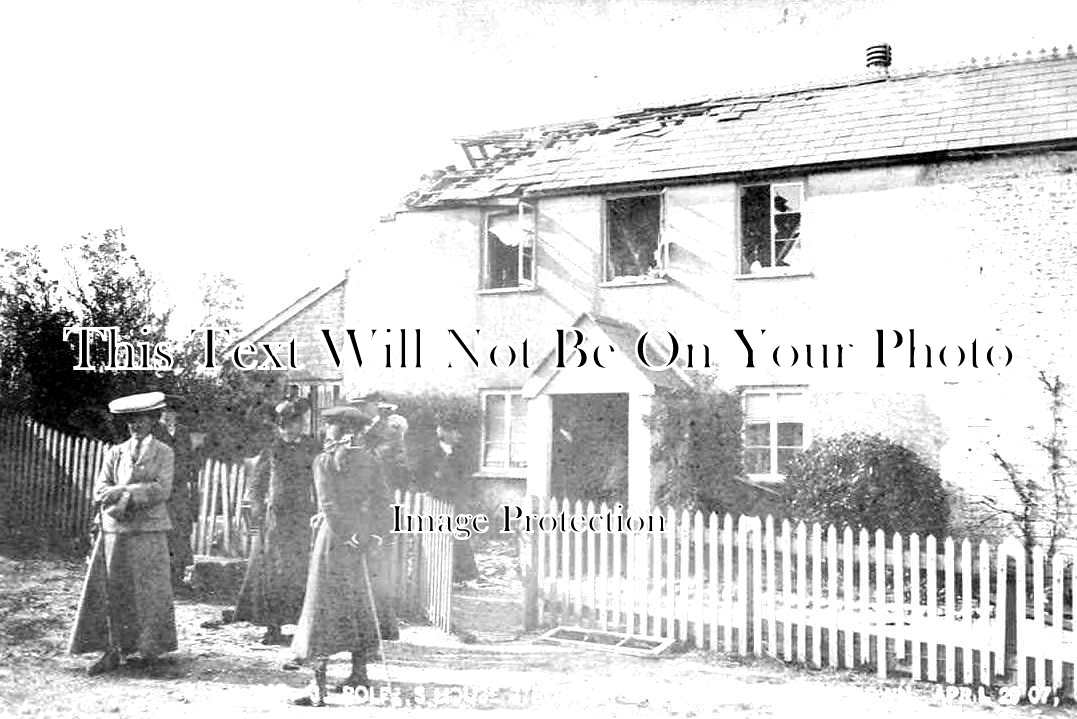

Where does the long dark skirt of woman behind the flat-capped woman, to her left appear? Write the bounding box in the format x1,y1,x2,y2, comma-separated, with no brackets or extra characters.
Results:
236,511,310,626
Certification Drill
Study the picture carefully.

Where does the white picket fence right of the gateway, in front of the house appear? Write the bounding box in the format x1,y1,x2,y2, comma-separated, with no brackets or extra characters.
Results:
530,499,1077,696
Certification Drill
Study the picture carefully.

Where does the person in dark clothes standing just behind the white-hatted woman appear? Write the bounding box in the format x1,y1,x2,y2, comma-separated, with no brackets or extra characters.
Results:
153,407,198,592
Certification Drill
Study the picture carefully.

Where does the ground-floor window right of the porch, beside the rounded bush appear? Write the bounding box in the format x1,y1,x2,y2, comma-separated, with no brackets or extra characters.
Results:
744,390,807,478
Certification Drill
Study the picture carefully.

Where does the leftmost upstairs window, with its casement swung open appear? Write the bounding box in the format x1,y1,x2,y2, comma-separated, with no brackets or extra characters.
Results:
482,202,536,290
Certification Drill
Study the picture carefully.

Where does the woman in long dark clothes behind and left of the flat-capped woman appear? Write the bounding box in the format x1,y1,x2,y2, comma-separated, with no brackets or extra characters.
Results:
235,399,319,644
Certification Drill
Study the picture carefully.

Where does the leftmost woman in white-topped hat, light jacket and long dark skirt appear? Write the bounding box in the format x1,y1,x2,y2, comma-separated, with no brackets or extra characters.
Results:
70,392,177,675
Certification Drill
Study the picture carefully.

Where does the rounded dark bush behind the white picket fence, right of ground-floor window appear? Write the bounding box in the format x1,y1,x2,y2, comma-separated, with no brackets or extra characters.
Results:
783,433,949,534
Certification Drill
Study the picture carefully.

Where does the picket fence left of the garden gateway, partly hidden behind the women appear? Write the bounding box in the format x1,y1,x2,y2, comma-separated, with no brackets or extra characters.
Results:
0,414,453,631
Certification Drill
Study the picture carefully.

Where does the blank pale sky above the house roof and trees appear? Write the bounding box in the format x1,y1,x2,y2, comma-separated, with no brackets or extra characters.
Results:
0,0,1077,333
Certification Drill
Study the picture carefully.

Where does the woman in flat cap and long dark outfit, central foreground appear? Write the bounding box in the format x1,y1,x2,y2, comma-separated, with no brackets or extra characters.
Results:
292,407,389,706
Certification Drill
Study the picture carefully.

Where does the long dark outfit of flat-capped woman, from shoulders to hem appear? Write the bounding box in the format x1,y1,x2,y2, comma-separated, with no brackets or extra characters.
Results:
292,443,389,659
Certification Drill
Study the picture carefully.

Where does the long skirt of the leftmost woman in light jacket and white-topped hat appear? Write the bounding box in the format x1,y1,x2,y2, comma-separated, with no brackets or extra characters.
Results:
70,532,177,658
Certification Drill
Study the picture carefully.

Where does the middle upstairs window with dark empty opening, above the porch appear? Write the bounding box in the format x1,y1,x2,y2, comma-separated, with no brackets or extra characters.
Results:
605,195,667,281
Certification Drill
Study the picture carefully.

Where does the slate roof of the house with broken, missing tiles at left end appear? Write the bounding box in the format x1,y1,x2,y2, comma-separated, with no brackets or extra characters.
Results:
405,46,1077,209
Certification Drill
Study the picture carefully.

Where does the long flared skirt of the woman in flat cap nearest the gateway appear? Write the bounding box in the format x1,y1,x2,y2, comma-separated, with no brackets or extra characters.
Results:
292,522,378,659
